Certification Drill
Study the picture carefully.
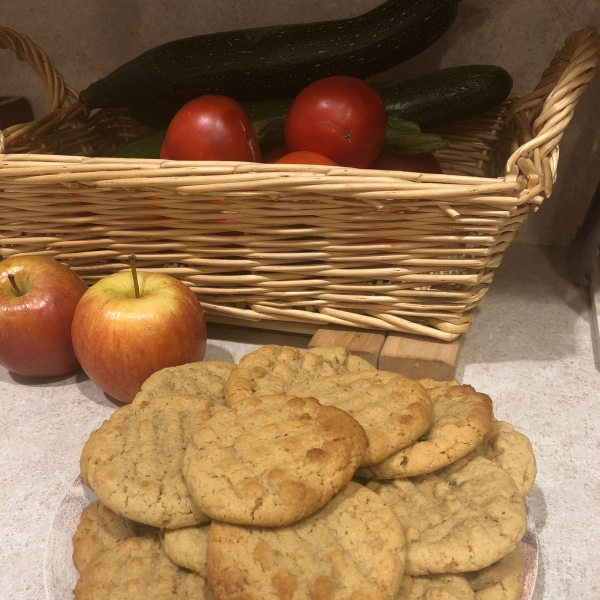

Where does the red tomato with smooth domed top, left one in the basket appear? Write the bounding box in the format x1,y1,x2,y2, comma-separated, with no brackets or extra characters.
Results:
160,94,261,162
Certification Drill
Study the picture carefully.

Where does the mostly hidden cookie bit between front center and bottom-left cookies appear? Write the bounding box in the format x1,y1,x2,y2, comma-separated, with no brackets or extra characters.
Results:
160,523,210,577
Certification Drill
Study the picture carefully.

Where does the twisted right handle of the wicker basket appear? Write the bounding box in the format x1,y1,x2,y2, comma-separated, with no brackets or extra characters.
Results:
506,27,600,198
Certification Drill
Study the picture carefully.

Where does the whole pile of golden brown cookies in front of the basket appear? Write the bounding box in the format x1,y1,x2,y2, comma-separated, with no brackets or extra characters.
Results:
73,346,536,600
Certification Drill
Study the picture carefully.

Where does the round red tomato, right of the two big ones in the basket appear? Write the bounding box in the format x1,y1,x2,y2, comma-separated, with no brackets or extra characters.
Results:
285,75,387,168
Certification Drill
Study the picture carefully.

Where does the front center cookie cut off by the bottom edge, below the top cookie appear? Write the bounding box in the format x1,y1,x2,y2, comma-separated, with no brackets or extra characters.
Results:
208,483,404,600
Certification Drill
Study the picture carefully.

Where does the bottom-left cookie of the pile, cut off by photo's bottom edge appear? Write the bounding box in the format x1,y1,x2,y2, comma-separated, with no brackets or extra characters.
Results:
74,535,214,600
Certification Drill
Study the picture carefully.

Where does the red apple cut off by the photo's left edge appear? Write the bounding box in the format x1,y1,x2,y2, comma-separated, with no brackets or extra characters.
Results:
0,256,87,377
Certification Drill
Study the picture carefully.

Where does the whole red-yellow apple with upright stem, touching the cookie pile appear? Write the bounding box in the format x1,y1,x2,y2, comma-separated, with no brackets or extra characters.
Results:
72,262,206,402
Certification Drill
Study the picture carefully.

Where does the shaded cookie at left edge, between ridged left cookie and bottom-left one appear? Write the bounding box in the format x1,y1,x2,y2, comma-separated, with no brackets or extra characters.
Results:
73,500,152,573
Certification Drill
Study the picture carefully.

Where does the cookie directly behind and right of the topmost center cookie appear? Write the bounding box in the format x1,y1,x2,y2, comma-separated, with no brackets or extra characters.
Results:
289,370,432,465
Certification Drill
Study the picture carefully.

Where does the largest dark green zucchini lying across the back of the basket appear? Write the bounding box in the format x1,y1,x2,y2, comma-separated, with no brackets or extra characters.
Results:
80,0,458,112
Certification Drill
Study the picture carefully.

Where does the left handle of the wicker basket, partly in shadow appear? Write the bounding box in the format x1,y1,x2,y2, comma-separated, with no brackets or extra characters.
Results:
0,27,79,111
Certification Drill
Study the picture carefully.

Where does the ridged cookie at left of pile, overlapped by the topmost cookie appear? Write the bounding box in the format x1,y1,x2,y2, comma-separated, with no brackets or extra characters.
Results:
80,395,213,529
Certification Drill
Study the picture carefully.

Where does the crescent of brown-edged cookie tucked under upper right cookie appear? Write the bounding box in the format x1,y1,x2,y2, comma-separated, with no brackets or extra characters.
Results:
357,385,493,479
